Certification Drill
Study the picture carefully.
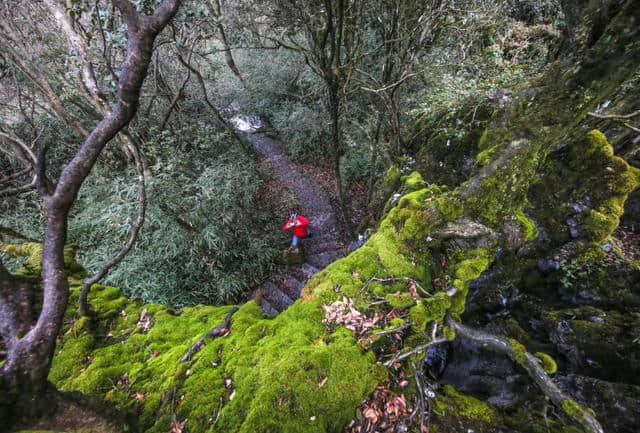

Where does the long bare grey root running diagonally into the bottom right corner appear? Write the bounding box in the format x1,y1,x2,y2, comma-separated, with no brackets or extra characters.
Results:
447,316,604,433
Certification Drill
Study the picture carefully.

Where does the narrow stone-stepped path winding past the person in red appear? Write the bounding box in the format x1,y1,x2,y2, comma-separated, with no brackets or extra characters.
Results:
252,134,346,316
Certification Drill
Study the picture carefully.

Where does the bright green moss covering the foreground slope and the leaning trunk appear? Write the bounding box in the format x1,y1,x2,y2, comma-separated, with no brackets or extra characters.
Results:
7,3,638,432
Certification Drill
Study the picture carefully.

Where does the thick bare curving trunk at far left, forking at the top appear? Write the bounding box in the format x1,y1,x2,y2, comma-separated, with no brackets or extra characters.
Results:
0,0,180,416
